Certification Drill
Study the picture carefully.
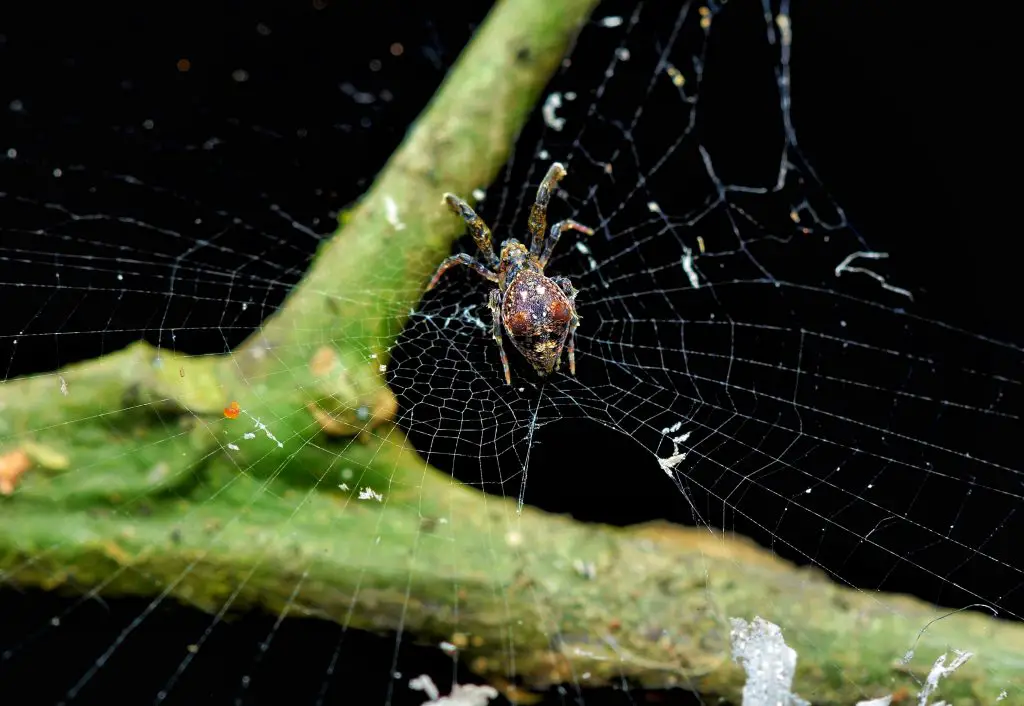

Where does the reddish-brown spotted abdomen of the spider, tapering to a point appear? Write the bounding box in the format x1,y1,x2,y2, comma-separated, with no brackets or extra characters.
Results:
502,271,575,375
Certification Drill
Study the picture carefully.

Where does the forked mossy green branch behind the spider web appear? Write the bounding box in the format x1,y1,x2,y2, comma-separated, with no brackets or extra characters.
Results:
0,0,1024,704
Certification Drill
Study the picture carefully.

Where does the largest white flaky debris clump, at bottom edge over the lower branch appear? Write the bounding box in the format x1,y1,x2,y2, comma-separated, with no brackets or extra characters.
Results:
729,616,810,706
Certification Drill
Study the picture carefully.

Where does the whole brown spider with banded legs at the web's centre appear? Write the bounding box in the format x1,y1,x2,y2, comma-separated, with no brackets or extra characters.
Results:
427,162,594,384
